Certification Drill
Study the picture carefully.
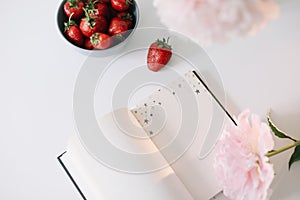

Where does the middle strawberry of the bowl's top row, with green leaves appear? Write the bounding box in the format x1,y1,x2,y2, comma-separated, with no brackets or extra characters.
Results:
85,0,110,19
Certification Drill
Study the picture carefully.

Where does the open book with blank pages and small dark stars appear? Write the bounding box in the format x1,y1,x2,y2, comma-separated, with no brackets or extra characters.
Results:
60,71,228,200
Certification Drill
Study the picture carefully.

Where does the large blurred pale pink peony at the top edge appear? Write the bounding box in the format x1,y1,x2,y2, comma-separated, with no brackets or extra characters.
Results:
154,0,279,45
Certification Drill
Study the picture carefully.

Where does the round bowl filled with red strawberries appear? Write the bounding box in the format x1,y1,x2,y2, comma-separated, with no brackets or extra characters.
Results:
57,0,139,56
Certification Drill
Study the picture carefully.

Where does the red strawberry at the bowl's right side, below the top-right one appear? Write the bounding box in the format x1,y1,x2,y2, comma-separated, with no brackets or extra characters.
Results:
108,17,132,35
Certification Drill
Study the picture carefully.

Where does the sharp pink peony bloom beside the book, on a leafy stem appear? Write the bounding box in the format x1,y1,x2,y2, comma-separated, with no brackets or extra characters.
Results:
214,111,274,200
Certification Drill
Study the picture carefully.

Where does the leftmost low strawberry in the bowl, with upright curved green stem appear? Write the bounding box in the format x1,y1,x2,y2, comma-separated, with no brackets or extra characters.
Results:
64,13,83,46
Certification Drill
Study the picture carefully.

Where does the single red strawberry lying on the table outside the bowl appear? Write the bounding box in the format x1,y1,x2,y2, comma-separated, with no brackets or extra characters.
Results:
147,38,172,72
